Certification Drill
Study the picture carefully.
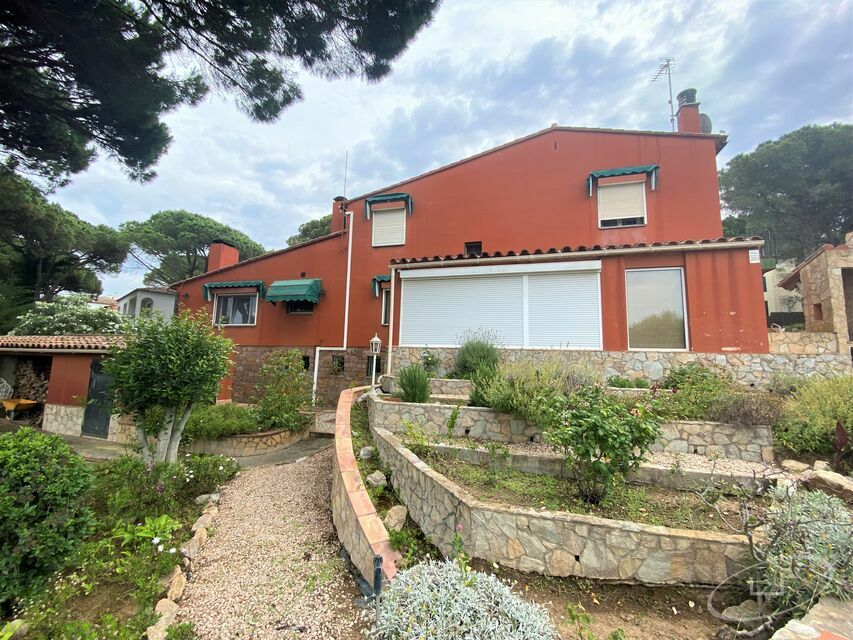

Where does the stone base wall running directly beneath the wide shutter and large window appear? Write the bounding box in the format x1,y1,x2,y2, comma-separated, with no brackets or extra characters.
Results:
391,347,853,387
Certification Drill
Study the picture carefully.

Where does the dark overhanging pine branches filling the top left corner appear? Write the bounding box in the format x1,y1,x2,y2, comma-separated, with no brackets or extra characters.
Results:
0,0,438,181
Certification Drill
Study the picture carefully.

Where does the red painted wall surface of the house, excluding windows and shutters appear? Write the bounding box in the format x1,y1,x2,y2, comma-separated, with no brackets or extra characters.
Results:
176,120,768,390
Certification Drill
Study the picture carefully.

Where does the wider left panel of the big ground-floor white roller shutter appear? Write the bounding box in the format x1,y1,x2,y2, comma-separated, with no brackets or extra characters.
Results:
400,275,524,347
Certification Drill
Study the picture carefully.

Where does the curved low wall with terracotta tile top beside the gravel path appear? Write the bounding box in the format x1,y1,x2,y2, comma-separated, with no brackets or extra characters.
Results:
332,387,400,586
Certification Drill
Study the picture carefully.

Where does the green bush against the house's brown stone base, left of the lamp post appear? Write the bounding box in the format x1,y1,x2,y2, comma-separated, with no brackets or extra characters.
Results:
255,349,312,431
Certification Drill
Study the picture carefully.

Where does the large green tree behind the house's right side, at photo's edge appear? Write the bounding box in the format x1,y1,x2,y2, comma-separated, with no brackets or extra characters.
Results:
720,123,853,261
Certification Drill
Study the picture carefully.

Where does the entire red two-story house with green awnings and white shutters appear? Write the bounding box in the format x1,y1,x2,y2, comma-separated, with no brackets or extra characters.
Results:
174,90,768,401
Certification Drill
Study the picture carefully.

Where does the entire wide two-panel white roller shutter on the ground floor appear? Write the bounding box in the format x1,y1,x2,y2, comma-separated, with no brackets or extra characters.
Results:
400,262,602,349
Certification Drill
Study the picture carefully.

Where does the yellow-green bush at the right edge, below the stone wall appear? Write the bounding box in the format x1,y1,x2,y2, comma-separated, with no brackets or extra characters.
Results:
774,376,853,454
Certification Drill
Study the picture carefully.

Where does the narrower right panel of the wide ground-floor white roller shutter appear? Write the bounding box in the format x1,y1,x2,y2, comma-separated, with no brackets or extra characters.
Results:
527,271,601,349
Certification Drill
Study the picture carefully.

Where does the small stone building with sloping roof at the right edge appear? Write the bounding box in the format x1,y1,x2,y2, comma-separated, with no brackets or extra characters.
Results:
778,232,853,355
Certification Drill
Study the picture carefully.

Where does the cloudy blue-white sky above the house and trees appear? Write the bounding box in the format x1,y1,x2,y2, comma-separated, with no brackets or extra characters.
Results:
55,0,853,295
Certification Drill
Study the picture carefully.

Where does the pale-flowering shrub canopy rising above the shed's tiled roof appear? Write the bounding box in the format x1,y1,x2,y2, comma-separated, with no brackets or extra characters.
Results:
10,293,125,336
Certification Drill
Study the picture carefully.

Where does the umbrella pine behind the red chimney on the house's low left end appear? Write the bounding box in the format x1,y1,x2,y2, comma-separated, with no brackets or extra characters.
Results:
121,209,264,286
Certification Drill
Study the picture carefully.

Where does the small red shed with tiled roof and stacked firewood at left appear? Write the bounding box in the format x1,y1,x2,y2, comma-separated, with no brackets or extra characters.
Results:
0,335,136,442
